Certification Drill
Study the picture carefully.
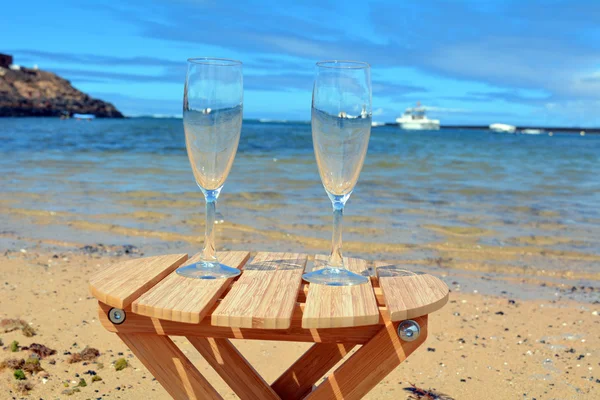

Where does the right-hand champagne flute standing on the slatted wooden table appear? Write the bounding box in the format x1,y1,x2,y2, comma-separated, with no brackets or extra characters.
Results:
303,61,372,286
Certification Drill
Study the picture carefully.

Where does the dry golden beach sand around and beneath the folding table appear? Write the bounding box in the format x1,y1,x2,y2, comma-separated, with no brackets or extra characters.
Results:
0,246,600,400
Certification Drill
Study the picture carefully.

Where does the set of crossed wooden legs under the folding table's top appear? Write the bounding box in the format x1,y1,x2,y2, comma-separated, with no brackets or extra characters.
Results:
108,309,427,400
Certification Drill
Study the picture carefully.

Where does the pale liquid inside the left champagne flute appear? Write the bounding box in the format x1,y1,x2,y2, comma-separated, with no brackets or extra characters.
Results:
183,106,242,190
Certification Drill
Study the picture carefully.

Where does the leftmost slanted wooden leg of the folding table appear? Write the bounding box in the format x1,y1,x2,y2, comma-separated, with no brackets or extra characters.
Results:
119,334,222,400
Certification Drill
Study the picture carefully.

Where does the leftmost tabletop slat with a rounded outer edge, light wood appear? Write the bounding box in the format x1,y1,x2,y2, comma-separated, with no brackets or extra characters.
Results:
89,254,187,308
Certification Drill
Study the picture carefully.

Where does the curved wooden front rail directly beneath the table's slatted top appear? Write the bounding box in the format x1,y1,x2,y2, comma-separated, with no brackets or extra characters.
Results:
98,303,387,344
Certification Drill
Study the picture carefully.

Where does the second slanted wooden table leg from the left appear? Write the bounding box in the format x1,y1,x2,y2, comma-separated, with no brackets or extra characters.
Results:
187,336,279,400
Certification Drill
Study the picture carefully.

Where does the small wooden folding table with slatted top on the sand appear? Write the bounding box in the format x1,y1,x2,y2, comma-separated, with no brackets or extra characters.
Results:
90,251,448,400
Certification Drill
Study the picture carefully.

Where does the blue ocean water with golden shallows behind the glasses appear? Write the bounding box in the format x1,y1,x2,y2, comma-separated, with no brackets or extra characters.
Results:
0,118,600,296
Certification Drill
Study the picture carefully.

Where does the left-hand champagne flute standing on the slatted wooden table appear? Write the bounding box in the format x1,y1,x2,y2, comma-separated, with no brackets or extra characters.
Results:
177,57,244,279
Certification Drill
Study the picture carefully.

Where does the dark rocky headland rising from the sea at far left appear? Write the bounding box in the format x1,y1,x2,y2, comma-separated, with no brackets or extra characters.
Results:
0,54,123,118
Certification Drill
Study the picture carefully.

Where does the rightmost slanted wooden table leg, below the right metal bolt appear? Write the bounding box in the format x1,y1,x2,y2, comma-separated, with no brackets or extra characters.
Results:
306,315,427,400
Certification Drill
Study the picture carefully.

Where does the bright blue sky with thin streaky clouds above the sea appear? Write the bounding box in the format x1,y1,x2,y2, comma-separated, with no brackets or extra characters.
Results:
0,0,600,126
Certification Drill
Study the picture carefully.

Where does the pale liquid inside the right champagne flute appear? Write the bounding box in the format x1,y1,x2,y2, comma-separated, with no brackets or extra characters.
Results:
312,107,371,196
